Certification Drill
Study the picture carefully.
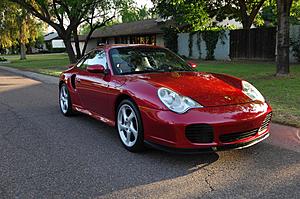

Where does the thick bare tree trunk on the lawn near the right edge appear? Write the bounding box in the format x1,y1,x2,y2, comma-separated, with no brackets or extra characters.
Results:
276,0,292,76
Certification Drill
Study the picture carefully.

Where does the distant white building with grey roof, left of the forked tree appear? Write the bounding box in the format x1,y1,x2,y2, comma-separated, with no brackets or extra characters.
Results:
43,32,66,52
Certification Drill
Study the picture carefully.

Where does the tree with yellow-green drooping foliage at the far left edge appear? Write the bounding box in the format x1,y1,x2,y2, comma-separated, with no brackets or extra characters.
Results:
0,0,42,60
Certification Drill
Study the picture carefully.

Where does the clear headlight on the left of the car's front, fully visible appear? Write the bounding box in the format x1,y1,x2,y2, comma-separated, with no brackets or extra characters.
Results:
157,88,203,113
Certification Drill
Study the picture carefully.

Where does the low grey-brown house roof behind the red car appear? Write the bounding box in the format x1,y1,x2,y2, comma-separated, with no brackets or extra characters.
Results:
92,19,170,38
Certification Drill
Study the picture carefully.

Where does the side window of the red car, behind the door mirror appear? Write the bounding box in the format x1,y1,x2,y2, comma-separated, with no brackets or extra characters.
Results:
77,50,107,70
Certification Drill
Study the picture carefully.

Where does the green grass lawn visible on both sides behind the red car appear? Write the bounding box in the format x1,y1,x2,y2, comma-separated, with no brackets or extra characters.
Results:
2,54,300,127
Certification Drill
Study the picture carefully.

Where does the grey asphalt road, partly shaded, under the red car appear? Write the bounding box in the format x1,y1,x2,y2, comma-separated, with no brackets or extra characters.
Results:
0,70,300,199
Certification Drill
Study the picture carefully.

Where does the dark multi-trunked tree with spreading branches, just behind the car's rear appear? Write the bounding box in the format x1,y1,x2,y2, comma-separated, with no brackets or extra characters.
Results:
10,0,119,63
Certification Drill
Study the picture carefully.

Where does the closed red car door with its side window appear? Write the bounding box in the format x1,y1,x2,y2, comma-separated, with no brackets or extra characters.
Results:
76,50,109,117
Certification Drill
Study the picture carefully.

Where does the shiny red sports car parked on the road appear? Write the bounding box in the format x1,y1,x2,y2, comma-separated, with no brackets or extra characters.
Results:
59,45,272,153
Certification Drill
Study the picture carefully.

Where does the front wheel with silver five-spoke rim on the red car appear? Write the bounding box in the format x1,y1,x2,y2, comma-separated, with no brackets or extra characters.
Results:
116,99,144,152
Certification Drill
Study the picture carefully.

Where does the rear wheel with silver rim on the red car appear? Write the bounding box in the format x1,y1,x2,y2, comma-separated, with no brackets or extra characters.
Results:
59,83,74,116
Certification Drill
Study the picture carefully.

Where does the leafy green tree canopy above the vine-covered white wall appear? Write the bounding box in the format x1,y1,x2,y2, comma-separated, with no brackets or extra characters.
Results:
153,0,266,30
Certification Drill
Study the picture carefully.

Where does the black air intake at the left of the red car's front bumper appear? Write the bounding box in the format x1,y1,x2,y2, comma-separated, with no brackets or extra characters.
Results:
185,124,214,143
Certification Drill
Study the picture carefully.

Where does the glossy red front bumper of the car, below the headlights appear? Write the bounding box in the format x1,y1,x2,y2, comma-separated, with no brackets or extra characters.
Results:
140,102,272,151
